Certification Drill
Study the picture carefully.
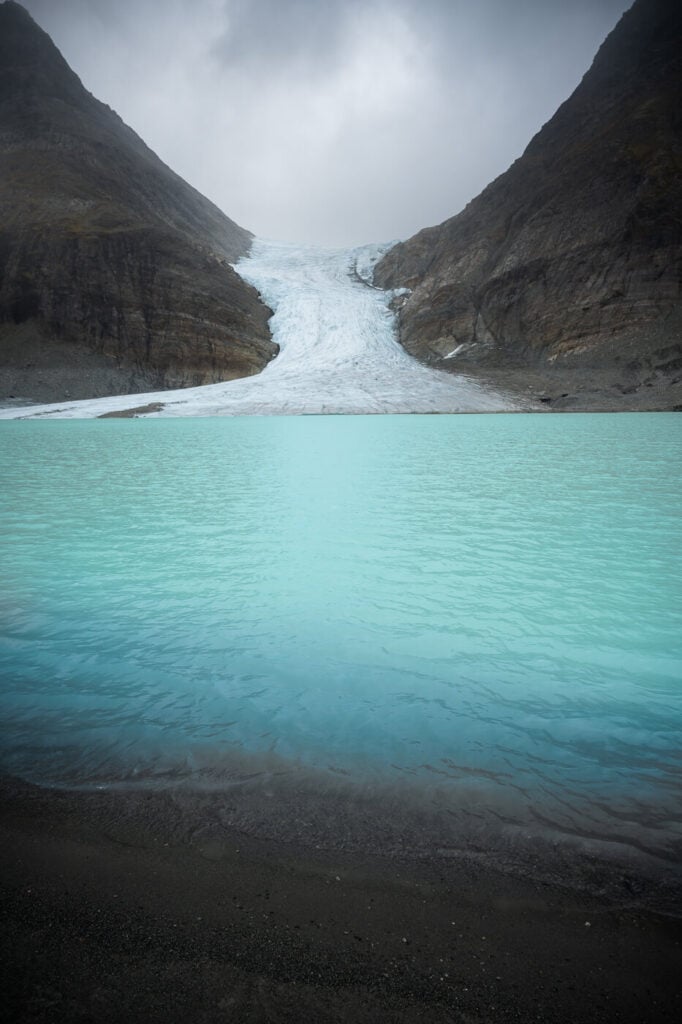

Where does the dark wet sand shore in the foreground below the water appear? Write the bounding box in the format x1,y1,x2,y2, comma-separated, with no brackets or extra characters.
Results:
0,779,682,1024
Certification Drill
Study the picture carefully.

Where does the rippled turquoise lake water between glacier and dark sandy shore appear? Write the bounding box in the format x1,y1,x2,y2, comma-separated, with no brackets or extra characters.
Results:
0,414,682,858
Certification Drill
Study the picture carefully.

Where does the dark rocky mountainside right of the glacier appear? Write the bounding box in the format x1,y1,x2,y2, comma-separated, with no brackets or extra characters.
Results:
375,0,682,408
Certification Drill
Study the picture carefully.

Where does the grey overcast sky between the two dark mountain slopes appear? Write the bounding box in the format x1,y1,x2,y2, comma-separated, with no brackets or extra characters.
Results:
23,0,631,245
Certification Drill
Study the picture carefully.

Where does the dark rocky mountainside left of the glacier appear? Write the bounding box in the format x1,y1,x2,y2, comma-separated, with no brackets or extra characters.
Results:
0,2,276,401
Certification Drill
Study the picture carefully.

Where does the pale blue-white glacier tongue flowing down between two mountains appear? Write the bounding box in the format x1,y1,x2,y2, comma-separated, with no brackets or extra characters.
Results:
0,240,518,418
